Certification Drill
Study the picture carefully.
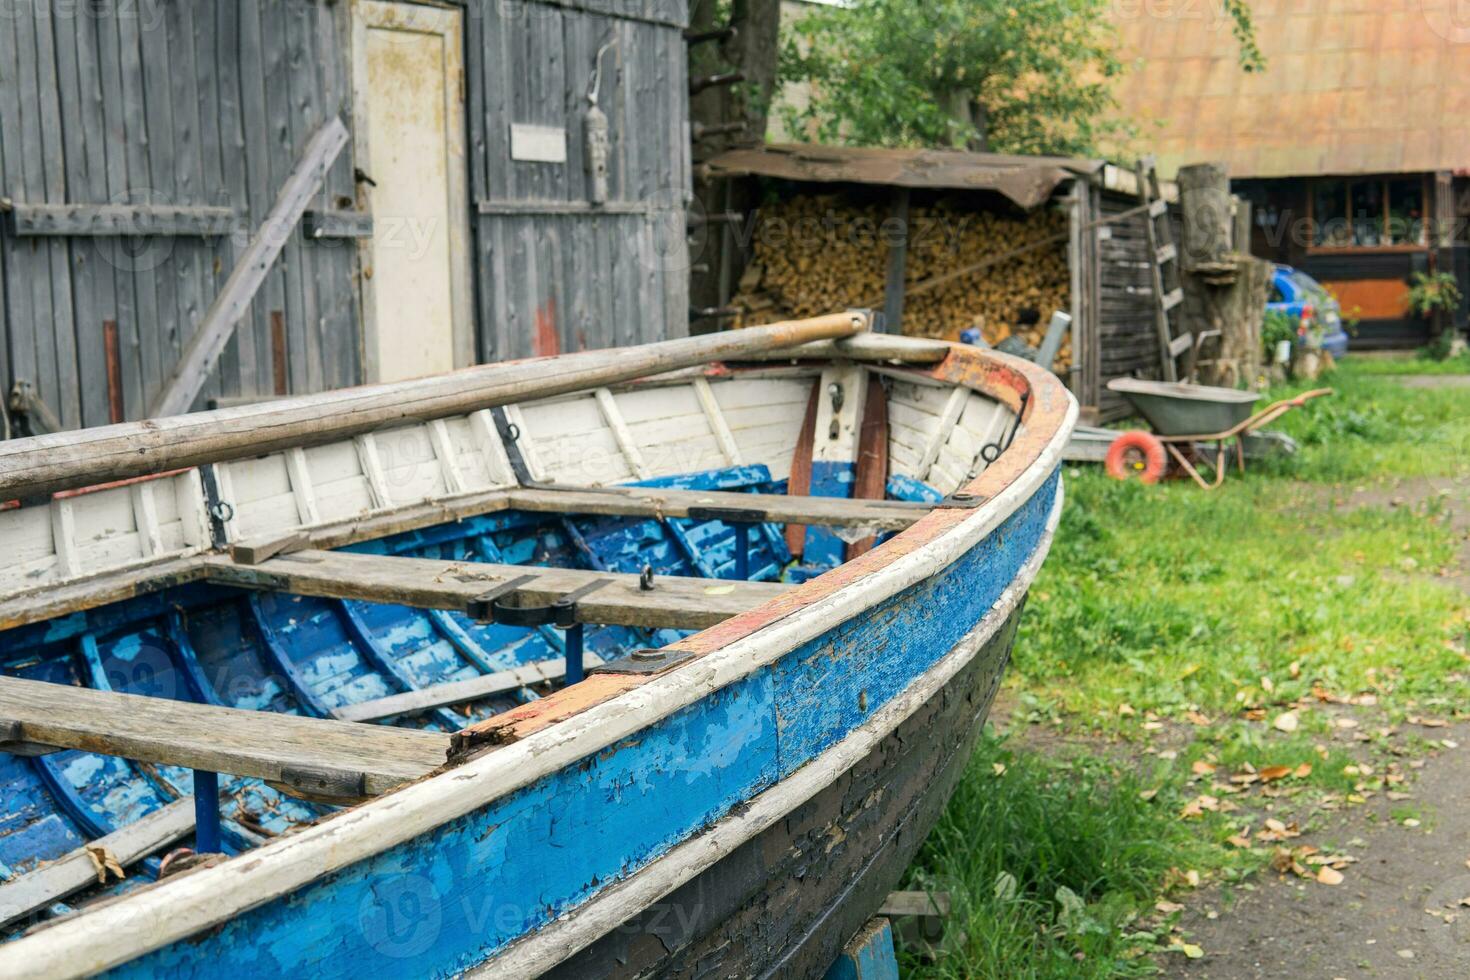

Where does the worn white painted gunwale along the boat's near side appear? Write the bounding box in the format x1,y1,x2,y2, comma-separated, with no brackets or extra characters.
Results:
0,348,1078,979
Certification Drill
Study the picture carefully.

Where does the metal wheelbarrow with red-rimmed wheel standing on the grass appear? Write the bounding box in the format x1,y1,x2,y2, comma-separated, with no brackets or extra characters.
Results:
1104,378,1333,489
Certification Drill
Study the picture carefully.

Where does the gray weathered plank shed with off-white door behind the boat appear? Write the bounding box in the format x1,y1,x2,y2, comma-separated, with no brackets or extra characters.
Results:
0,0,691,430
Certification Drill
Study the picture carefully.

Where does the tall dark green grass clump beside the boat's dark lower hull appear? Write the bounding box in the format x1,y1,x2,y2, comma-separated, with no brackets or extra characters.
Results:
904,736,1208,980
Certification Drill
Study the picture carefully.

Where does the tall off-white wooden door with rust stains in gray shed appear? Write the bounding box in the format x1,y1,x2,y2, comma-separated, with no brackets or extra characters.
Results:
353,0,473,382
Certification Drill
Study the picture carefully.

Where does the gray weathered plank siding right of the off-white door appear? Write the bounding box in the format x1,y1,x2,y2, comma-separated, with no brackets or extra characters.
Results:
467,0,691,361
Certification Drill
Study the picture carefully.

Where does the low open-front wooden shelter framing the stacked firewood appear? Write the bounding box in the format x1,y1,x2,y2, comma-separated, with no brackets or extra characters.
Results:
694,144,1177,422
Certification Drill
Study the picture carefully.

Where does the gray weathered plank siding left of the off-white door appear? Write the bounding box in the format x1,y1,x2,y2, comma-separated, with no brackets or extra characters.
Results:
0,0,359,426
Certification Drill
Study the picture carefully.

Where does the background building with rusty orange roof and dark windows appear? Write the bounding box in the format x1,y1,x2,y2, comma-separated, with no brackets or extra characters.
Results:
1113,0,1470,347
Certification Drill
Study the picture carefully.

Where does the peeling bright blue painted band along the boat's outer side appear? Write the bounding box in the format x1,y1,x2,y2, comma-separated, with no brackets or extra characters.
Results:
97,476,1058,979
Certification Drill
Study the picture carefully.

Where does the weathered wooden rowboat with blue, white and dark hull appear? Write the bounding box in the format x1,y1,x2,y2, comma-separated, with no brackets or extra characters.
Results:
0,313,1076,977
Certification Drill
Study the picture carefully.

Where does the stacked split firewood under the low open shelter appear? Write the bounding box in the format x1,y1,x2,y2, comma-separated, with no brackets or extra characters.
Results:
732,195,1072,375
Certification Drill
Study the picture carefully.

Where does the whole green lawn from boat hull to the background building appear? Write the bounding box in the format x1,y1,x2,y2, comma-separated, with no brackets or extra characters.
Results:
907,361,1470,979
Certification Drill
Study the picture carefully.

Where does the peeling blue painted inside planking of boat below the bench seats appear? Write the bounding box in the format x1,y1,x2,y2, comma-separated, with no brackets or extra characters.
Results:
0,466,941,936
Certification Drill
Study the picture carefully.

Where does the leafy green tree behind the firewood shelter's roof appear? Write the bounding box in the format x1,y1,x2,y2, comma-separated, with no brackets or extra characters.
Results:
781,0,1264,154
